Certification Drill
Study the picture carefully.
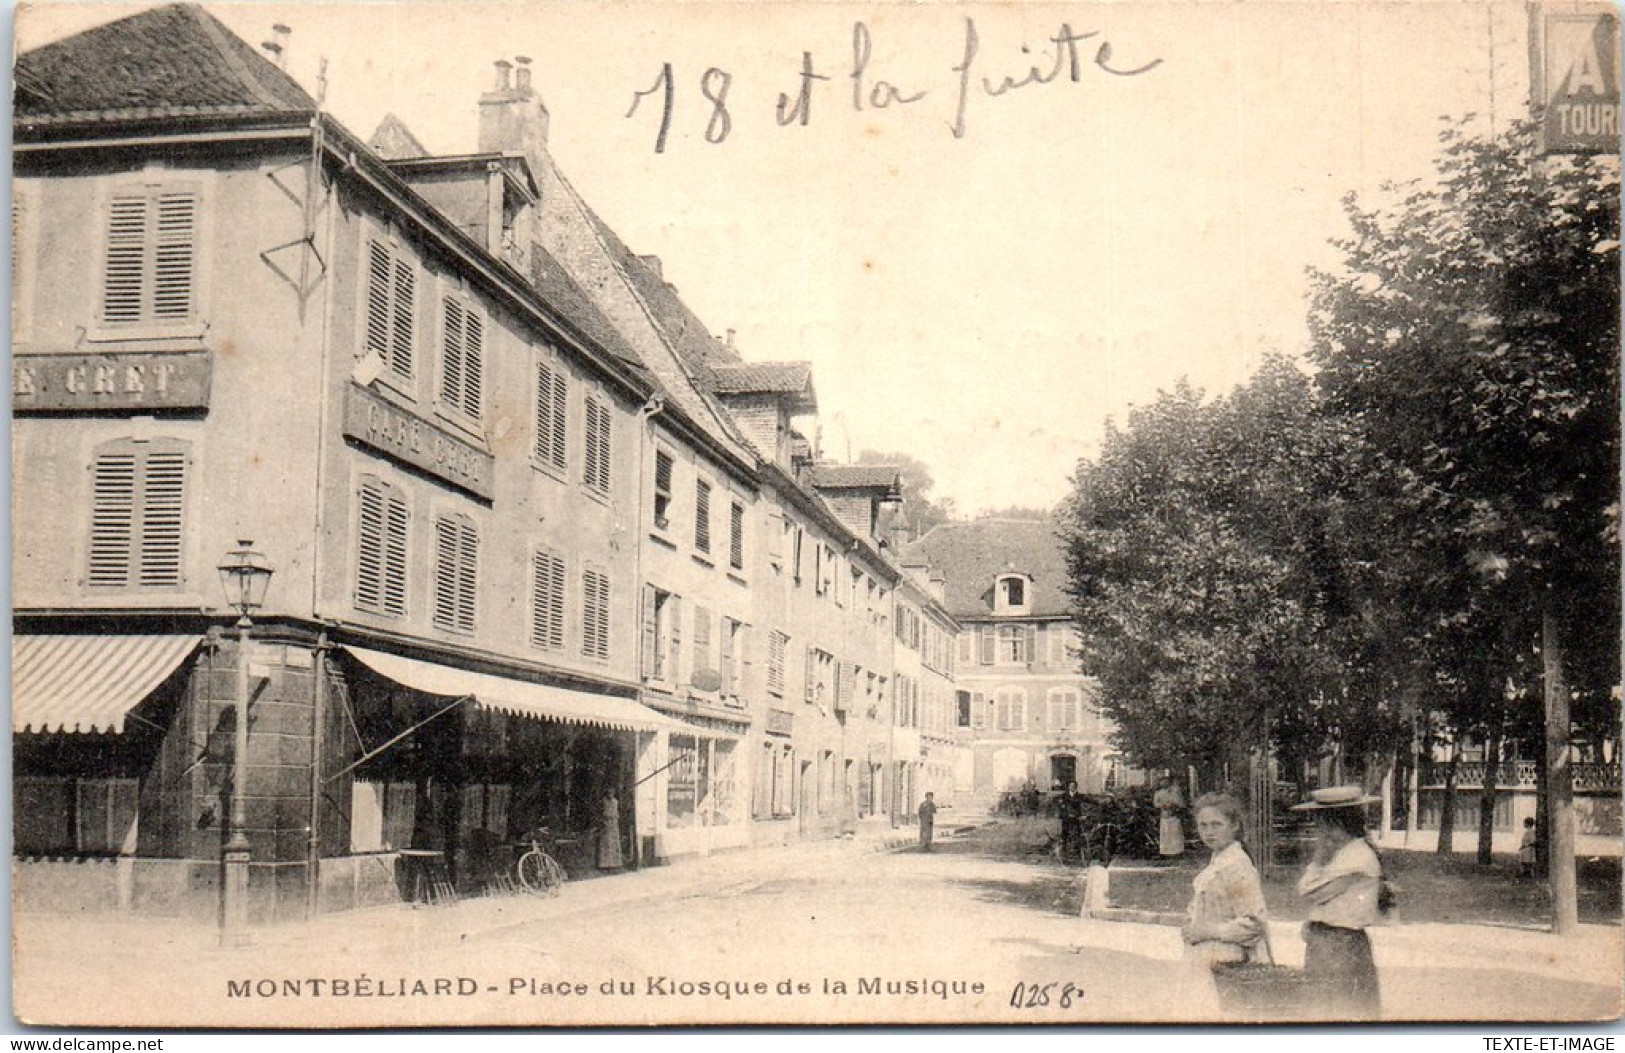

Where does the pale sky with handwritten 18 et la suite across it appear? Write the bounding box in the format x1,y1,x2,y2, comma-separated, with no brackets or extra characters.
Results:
16,0,1529,514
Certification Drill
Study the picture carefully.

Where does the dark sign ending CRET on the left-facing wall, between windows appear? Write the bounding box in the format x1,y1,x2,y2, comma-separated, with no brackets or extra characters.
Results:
11,351,211,413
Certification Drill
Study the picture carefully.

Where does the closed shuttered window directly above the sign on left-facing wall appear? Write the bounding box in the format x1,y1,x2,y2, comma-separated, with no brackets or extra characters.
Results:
101,190,198,325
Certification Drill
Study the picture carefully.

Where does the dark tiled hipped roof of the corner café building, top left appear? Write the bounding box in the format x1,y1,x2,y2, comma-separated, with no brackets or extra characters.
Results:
13,3,317,130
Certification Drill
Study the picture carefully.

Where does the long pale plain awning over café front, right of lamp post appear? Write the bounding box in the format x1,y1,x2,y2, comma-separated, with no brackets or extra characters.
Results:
345,647,689,731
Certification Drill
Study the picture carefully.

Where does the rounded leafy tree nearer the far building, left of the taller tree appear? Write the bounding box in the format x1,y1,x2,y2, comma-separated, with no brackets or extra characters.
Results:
1061,358,1399,772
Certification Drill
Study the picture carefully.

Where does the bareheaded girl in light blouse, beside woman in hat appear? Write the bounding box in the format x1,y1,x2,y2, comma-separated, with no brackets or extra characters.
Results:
1180,793,1264,1011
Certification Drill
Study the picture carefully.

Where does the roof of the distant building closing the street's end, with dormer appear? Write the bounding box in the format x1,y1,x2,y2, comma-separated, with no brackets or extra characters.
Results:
902,518,1073,621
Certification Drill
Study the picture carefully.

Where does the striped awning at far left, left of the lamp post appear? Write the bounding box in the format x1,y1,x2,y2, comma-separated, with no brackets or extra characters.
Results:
11,635,203,733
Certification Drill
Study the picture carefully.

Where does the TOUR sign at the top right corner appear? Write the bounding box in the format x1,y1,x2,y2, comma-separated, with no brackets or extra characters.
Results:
1536,11,1620,156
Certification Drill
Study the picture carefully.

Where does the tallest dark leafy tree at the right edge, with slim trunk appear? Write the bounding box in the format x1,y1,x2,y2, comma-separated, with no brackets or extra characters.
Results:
1310,122,1620,928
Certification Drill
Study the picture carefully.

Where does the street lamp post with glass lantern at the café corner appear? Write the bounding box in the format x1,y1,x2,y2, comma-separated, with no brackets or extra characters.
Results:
219,541,271,946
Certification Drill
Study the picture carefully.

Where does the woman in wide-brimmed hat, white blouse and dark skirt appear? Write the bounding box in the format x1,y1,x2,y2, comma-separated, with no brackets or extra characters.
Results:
1292,787,1383,1021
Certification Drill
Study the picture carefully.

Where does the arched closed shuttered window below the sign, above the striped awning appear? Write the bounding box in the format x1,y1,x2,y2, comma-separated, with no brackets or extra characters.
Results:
86,439,189,588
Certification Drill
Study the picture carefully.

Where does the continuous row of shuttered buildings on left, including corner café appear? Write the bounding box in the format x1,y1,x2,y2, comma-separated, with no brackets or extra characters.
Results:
13,5,952,921
